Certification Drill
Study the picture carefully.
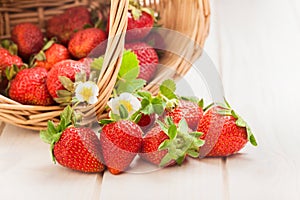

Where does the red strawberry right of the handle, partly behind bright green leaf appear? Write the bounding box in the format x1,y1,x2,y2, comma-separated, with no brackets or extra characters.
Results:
125,42,158,82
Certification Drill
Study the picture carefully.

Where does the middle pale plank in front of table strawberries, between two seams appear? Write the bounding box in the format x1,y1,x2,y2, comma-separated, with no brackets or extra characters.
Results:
101,159,223,200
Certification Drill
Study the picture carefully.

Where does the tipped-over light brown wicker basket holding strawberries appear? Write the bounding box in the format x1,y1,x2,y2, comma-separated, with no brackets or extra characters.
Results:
0,0,210,130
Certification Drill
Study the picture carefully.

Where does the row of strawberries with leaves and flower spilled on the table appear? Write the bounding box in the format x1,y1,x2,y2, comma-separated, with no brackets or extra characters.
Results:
40,77,257,174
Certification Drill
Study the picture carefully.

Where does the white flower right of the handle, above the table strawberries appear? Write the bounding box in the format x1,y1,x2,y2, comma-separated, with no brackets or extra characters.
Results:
107,92,141,116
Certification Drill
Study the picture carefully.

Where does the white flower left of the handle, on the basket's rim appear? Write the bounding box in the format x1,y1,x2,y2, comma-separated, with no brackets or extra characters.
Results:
75,81,99,104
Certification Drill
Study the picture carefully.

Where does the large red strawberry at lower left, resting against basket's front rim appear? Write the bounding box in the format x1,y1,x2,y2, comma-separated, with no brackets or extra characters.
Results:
9,67,54,106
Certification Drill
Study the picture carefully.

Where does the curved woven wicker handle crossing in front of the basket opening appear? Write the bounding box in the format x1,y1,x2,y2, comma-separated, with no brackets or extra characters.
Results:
91,0,129,118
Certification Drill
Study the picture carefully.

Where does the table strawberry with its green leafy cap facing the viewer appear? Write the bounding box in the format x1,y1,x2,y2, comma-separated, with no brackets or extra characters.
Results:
139,118,204,167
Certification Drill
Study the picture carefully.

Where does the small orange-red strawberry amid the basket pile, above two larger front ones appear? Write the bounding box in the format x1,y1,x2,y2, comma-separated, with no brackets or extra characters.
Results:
36,44,70,71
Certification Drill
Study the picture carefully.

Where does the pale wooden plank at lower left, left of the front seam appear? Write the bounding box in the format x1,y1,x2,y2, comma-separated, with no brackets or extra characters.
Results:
0,125,102,200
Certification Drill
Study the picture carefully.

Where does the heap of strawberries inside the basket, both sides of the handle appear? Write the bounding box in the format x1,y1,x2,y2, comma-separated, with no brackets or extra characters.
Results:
0,1,162,106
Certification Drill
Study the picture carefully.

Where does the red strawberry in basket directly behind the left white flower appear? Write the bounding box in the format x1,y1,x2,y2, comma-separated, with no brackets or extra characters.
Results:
47,60,89,98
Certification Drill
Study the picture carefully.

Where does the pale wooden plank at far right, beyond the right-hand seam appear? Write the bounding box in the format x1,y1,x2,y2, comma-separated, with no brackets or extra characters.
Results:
216,0,300,200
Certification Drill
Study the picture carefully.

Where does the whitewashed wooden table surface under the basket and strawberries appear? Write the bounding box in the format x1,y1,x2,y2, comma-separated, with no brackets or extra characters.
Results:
0,0,300,200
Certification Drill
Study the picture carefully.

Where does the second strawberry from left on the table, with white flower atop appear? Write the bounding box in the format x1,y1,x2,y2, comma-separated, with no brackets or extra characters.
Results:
100,93,143,174
